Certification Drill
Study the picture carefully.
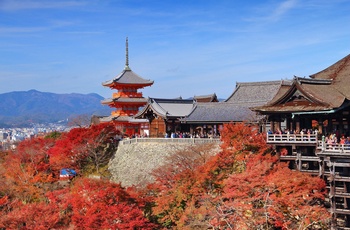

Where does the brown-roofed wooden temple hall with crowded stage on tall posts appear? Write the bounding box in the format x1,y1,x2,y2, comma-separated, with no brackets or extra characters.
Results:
252,55,350,229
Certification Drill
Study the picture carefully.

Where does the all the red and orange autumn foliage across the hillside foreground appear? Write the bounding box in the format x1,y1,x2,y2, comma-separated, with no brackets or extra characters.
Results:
0,124,330,230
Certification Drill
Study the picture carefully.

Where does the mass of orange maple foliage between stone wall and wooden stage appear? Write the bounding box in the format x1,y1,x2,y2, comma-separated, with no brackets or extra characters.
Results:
149,124,329,229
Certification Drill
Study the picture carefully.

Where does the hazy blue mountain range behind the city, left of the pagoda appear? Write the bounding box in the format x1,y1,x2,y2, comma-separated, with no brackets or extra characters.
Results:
0,90,111,128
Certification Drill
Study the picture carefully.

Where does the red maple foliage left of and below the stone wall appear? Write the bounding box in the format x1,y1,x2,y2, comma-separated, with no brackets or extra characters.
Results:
0,124,156,229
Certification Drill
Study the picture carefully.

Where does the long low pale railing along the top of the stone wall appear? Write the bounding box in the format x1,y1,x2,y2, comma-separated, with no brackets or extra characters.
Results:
119,138,221,145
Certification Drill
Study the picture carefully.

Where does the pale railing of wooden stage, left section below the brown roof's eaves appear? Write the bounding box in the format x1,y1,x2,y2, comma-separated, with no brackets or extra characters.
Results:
266,134,317,144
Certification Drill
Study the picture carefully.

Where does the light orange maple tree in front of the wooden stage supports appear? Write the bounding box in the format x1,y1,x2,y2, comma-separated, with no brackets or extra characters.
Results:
211,155,330,229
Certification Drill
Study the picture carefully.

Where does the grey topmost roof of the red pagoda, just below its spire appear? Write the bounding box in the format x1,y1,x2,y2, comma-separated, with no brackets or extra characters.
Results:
102,69,154,86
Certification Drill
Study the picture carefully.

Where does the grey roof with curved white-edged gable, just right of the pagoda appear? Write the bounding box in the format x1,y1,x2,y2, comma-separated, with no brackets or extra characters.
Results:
135,98,194,118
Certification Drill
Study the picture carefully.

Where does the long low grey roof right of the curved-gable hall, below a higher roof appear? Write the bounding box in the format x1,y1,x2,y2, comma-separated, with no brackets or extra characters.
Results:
182,102,258,123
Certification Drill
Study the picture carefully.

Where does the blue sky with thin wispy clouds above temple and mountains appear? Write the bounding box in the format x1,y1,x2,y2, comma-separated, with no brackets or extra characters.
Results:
0,0,350,99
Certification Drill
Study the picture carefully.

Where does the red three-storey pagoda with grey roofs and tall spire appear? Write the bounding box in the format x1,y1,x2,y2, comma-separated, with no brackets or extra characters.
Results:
101,38,154,136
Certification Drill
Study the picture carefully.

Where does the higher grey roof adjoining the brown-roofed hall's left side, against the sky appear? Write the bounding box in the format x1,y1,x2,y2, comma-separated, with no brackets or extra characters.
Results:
225,80,291,107
